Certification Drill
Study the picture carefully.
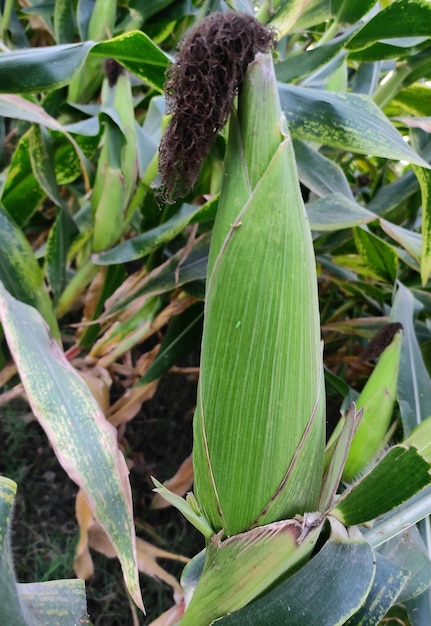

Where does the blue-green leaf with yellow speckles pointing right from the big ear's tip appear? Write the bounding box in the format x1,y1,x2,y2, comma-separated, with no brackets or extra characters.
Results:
279,85,429,168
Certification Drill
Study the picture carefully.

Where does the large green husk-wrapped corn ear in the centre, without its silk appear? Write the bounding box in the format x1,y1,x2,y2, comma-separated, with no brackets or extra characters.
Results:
193,53,325,535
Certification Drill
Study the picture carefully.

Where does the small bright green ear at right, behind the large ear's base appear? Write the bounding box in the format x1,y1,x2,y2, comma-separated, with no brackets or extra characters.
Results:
343,331,402,482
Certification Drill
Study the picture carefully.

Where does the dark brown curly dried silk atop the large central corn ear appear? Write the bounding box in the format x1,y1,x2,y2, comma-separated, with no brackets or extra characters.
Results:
159,13,276,199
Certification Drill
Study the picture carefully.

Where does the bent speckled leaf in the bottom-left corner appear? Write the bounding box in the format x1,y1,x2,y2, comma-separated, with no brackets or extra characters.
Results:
0,476,90,626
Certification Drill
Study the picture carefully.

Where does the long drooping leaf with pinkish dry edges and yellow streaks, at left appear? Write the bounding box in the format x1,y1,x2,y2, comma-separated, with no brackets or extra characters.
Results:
0,283,143,609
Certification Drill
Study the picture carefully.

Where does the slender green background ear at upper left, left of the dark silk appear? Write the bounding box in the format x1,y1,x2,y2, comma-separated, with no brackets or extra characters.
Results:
91,67,138,252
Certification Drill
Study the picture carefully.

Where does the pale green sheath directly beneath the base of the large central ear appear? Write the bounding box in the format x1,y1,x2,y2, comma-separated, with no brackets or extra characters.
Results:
181,518,321,626
